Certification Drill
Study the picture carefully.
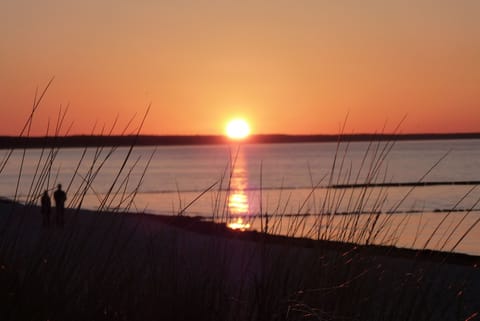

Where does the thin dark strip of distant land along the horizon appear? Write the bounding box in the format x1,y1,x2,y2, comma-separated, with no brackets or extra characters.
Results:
0,133,480,149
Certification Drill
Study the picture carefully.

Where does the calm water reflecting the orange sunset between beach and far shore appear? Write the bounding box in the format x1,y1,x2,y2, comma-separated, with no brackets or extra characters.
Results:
0,139,480,255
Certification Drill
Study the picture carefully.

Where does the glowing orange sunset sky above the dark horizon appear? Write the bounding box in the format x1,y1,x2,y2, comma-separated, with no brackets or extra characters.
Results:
0,0,480,136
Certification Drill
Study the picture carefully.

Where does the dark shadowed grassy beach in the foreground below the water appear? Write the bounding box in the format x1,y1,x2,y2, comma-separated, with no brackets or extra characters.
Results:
0,200,480,320
